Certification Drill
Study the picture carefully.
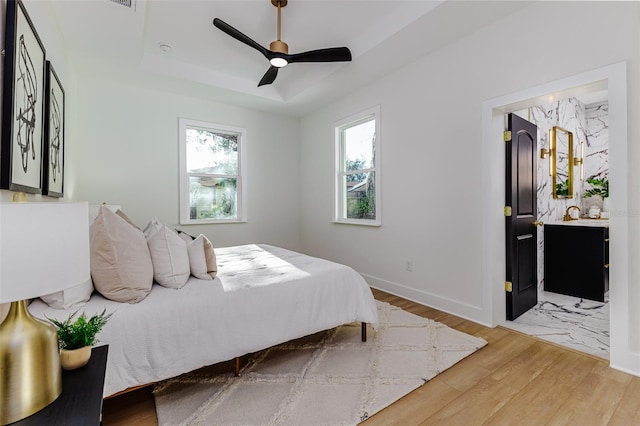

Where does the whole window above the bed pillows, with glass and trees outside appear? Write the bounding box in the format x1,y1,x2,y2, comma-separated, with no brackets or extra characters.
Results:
178,118,247,224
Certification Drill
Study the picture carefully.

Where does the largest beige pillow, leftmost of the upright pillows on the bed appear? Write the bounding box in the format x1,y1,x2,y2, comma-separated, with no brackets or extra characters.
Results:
90,206,153,303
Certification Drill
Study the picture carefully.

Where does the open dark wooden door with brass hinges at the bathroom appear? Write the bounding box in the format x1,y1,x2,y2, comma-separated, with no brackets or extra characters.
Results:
505,114,538,320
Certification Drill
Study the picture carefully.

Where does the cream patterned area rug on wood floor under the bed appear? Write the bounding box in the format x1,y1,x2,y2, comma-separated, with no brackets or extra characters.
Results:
153,301,487,426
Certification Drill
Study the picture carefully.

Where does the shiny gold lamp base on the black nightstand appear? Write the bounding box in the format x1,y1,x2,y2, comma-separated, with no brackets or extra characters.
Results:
0,300,62,425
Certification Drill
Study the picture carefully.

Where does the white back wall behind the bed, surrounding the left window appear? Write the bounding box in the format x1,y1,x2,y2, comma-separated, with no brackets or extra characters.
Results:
71,78,299,249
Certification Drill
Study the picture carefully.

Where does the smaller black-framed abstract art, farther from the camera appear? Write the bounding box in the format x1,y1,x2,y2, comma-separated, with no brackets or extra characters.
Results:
42,61,65,197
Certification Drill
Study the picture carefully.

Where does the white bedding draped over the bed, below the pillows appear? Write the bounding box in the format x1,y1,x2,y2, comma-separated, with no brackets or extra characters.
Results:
29,244,378,396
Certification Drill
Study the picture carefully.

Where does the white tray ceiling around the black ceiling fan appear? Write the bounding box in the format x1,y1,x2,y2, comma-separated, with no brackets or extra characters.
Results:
50,0,527,116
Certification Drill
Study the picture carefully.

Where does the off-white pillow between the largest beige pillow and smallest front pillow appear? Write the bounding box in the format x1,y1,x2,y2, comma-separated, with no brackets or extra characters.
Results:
144,218,190,288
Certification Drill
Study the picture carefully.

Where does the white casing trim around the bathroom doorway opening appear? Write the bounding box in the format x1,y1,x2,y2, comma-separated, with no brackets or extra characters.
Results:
481,62,640,375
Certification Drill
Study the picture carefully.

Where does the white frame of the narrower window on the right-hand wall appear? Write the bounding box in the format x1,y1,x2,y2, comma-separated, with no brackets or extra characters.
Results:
333,105,382,226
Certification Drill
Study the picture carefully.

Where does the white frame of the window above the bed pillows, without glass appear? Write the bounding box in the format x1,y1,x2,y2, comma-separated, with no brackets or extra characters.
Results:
178,118,247,225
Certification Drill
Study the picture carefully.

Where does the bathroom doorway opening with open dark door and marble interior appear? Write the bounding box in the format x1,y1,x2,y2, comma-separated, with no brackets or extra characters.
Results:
503,105,609,359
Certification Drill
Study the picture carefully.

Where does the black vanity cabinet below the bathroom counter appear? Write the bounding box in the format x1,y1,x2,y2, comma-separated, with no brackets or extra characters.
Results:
544,225,609,302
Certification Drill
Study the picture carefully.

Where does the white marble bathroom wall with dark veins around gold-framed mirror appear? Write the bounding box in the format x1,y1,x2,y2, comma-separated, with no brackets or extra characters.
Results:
528,98,609,291
